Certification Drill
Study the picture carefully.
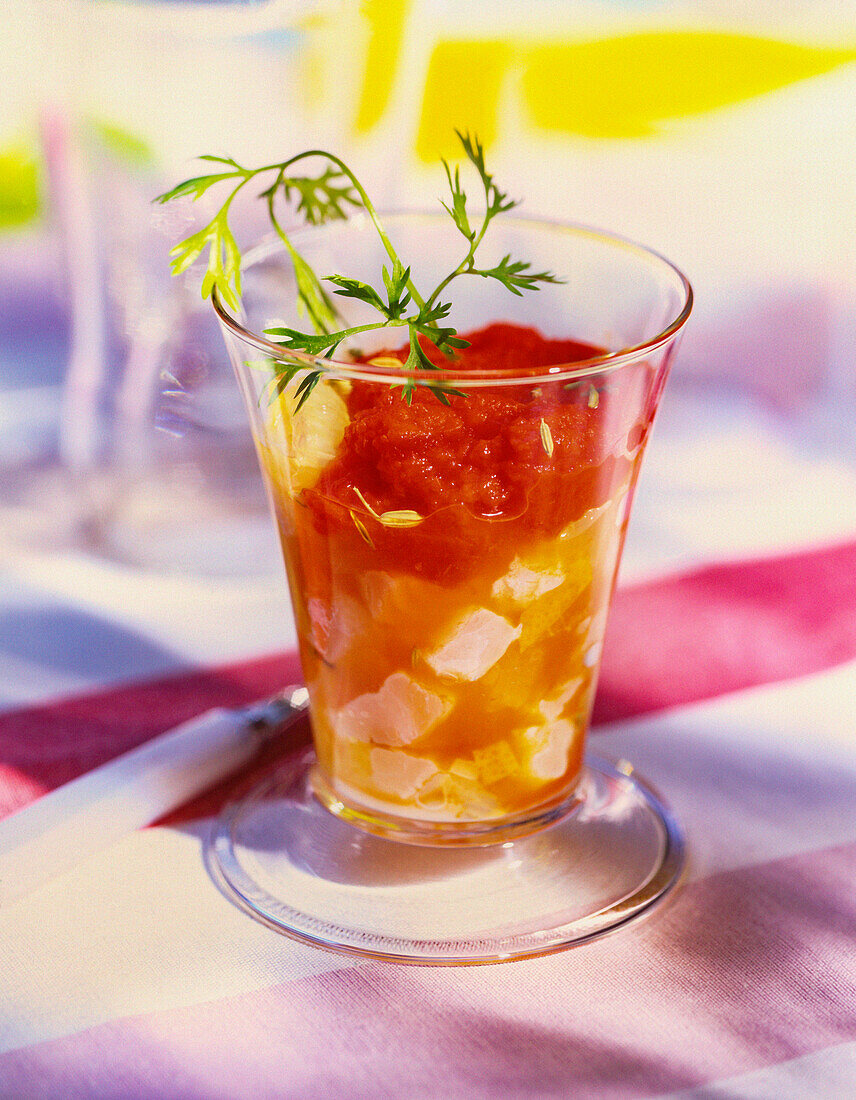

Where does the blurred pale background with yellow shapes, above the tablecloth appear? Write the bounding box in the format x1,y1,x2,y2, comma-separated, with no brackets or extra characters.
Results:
0,0,856,578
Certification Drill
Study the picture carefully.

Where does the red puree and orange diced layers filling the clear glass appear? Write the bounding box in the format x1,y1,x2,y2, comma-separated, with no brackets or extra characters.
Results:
260,325,656,823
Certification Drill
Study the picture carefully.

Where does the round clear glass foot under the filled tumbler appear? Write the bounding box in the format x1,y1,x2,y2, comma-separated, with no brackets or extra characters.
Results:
207,749,685,966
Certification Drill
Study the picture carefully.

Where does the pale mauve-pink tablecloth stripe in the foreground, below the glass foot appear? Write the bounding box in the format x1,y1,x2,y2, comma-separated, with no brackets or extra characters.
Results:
0,844,856,1100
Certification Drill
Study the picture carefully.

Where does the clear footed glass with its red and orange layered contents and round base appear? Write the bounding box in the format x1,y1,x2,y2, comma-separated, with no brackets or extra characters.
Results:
210,215,692,964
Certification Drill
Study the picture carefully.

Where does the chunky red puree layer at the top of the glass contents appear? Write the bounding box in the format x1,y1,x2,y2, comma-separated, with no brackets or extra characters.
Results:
304,323,644,582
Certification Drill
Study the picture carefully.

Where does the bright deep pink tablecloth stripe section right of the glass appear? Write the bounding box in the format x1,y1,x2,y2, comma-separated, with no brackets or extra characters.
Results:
593,541,856,723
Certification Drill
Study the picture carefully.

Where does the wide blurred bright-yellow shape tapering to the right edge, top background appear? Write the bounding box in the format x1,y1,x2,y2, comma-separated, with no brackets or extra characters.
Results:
407,31,856,162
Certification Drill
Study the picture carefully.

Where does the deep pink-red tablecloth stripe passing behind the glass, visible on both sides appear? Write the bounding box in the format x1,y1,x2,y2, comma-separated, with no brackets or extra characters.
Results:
0,541,856,823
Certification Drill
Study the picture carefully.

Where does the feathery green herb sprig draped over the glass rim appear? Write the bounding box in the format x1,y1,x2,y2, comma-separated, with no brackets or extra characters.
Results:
156,131,560,410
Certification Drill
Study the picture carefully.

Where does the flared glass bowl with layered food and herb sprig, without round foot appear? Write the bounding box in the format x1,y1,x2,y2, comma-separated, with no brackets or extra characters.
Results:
165,135,688,843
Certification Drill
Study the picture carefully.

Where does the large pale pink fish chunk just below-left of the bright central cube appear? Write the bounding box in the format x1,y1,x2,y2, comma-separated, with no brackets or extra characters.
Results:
333,672,451,745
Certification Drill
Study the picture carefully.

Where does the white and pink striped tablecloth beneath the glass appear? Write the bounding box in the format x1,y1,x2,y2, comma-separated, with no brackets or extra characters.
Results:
0,398,856,1100
